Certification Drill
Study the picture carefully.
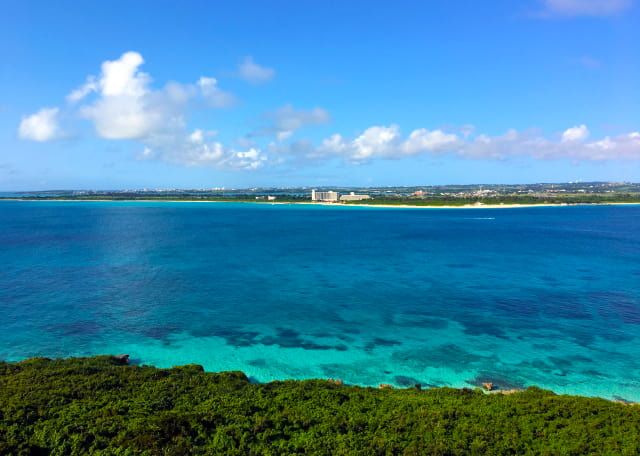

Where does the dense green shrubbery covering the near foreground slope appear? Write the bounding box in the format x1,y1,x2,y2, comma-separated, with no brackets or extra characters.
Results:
0,356,640,455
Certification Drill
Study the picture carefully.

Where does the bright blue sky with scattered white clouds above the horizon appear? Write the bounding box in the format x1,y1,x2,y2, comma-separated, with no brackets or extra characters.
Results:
0,0,640,191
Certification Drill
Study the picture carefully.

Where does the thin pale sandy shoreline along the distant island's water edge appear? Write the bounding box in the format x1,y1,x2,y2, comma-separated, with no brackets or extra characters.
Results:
0,198,640,209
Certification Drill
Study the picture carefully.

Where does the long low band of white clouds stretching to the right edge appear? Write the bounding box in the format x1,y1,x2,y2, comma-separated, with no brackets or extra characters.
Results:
274,125,640,163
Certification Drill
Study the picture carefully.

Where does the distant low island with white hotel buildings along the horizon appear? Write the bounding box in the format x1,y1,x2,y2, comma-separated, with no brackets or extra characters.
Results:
0,182,640,207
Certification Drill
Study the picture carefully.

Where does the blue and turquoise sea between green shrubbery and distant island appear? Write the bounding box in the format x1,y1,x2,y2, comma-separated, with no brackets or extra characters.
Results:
0,201,640,401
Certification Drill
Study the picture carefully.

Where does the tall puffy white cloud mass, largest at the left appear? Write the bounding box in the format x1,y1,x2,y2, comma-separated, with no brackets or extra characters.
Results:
58,52,266,169
